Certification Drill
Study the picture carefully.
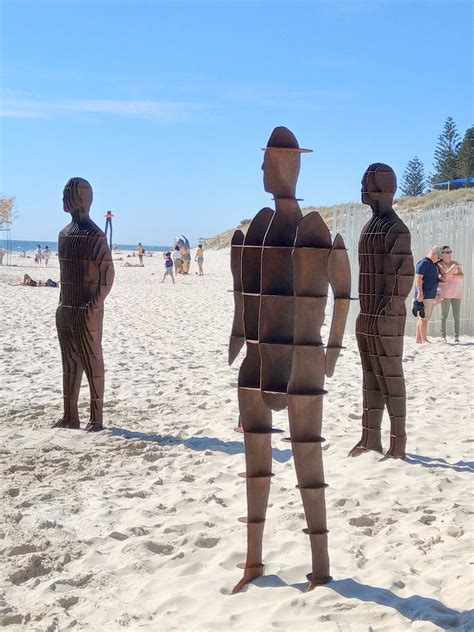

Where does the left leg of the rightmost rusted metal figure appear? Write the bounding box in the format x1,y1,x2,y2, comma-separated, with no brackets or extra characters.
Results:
348,333,385,456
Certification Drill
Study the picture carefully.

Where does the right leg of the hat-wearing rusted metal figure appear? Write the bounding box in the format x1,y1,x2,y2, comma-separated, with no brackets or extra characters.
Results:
288,395,332,591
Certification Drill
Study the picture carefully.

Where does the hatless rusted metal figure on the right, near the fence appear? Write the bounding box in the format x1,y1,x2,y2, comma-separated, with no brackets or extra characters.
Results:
349,163,414,458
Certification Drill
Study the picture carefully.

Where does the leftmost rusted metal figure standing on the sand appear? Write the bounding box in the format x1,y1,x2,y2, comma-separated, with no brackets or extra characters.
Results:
53,178,114,432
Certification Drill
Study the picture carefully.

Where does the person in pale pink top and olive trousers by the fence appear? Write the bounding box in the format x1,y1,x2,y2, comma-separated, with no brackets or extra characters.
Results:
438,246,464,342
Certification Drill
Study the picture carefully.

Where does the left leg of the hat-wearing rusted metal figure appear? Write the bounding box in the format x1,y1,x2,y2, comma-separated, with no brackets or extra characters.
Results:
232,388,272,594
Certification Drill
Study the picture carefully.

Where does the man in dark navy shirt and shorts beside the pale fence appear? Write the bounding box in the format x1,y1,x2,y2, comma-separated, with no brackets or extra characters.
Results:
414,246,443,344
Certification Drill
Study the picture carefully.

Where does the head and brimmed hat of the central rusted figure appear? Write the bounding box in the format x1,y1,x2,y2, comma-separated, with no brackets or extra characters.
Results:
262,127,311,199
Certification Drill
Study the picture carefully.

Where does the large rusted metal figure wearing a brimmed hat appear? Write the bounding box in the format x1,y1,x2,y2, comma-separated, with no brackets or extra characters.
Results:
229,127,350,592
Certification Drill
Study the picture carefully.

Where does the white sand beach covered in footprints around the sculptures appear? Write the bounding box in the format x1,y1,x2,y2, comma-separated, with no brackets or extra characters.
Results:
0,250,474,632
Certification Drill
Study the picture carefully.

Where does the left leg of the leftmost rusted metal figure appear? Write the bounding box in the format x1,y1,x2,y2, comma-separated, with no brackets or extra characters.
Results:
52,330,82,428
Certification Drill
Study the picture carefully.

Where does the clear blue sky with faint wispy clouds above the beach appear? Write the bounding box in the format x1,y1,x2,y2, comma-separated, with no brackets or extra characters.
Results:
0,0,473,244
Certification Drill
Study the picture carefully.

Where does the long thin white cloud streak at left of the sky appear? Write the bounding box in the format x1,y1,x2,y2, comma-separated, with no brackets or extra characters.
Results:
0,94,203,123
